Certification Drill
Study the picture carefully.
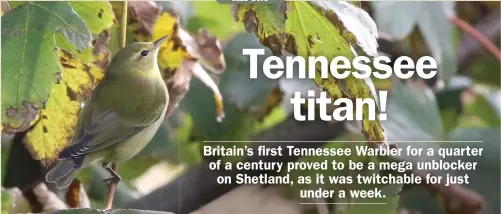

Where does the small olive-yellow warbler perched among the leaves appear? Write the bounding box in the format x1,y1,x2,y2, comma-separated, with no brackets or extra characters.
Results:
45,36,169,189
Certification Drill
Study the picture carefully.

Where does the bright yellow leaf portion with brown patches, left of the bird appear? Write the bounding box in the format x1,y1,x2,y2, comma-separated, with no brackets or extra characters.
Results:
25,50,103,165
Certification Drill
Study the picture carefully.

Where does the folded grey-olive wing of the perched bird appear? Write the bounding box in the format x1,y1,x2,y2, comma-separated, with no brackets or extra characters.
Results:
59,103,160,162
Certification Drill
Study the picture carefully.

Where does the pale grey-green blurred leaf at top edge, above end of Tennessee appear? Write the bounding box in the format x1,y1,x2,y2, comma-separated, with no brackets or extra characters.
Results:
371,1,457,81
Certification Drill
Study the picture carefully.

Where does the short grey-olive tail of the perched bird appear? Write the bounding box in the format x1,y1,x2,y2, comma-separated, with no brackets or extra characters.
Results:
45,159,78,189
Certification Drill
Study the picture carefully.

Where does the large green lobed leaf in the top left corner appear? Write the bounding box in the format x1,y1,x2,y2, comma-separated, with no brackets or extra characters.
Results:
2,2,92,132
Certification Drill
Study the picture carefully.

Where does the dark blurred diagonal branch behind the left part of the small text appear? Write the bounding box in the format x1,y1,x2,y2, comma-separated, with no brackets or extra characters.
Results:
125,117,345,214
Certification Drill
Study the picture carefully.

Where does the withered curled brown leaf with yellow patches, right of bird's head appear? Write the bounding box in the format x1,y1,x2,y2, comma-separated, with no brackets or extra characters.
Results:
143,12,226,121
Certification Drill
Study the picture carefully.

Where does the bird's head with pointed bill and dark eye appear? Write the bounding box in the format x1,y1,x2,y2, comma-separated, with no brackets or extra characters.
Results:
108,36,167,76
